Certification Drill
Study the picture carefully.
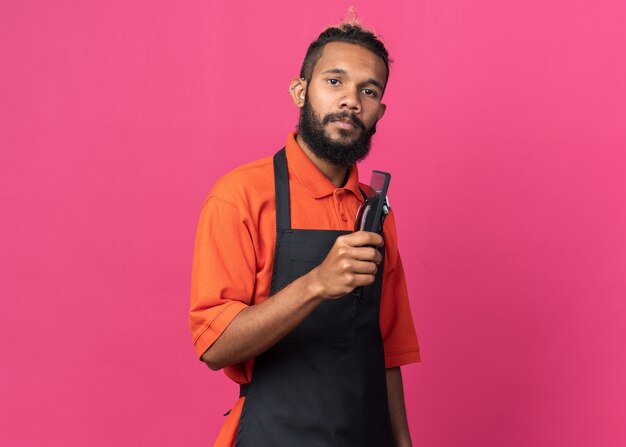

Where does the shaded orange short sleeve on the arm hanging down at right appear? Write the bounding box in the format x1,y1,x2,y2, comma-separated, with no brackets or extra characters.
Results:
380,212,420,368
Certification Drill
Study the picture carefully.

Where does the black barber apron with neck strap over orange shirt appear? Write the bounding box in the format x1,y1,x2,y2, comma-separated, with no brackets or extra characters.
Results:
235,148,393,447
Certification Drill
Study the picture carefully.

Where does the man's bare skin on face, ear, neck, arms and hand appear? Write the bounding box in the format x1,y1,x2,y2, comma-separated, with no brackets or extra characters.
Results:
202,42,411,447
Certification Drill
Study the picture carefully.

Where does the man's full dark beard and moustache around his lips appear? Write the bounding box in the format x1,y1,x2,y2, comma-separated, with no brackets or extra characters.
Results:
298,96,376,168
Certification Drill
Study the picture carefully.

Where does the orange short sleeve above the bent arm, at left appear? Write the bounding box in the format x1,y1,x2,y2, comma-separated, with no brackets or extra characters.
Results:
190,195,256,357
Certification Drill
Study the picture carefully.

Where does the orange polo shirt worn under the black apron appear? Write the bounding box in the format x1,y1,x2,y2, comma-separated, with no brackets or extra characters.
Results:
190,133,420,446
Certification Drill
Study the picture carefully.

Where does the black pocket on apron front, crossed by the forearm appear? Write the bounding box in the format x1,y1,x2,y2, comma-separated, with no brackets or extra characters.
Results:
286,259,357,343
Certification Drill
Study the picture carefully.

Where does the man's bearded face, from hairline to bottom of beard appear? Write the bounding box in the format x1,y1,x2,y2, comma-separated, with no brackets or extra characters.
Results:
298,42,387,167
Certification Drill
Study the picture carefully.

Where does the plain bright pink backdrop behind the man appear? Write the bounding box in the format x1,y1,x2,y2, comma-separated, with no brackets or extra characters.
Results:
0,0,626,447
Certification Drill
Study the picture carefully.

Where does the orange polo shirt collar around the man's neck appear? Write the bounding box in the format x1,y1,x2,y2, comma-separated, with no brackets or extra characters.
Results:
285,132,363,201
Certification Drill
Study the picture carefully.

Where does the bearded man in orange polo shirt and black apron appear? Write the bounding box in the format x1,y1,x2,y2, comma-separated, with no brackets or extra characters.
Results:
186,24,419,447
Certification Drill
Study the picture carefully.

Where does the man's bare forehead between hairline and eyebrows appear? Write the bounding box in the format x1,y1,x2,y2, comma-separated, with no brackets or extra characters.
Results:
313,42,387,85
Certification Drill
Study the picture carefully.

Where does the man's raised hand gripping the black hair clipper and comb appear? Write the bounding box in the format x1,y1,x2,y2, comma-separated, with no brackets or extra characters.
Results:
309,231,384,299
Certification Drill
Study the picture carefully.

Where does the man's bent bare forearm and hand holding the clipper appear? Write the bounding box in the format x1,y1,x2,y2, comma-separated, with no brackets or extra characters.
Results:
202,231,383,370
